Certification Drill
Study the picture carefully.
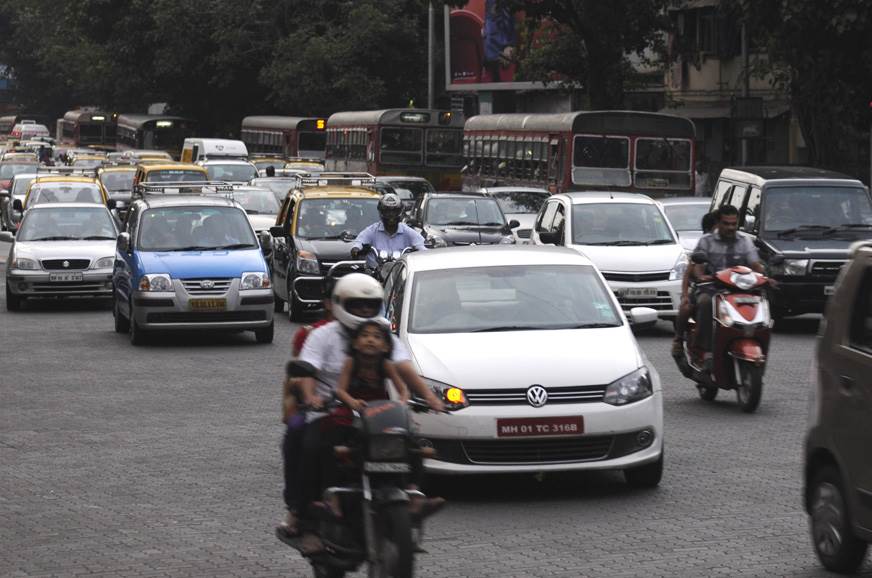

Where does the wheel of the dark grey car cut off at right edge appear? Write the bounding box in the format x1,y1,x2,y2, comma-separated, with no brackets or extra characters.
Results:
809,466,868,574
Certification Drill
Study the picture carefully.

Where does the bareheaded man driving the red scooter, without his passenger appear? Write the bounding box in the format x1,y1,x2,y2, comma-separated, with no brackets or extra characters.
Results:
693,205,772,367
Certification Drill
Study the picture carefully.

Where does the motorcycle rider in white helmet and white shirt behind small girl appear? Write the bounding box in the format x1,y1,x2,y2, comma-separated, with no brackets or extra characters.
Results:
298,273,445,552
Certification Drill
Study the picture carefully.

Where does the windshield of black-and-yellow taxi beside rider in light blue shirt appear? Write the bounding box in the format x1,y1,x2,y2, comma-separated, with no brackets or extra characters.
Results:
296,199,379,239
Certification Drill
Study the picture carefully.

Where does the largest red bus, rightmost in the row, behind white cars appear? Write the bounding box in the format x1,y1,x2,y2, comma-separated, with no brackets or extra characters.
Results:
463,111,696,197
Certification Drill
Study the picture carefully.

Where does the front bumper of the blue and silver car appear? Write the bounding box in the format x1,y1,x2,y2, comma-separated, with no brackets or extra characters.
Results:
132,279,275,330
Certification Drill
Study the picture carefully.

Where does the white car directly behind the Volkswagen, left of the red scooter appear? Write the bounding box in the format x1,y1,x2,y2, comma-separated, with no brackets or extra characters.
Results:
531,192,687,319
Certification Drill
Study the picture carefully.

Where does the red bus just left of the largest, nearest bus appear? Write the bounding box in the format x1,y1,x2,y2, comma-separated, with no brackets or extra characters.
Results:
325,108,463,190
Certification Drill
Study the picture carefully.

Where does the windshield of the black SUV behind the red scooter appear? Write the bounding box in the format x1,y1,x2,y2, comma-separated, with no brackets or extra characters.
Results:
763,186,872,231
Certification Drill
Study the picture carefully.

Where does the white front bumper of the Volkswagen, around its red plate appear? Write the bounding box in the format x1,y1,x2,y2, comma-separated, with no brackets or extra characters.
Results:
414,391,663,474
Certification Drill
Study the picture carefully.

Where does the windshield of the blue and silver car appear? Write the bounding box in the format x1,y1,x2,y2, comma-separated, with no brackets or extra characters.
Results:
137,206,258,251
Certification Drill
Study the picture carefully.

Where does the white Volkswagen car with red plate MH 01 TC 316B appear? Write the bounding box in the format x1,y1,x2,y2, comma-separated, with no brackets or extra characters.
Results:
385,246,663,487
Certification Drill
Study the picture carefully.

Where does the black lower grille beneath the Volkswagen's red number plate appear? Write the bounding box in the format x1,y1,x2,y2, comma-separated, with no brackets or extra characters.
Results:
462,436,614,464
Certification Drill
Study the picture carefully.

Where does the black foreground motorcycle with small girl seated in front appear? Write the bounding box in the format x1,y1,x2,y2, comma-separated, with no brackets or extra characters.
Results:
276,361,467,578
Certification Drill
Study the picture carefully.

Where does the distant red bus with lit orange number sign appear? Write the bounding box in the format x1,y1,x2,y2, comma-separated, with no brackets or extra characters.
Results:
240,116,326,159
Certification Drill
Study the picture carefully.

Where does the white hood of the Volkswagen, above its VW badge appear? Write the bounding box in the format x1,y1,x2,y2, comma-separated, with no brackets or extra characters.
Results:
406,326,644,389
